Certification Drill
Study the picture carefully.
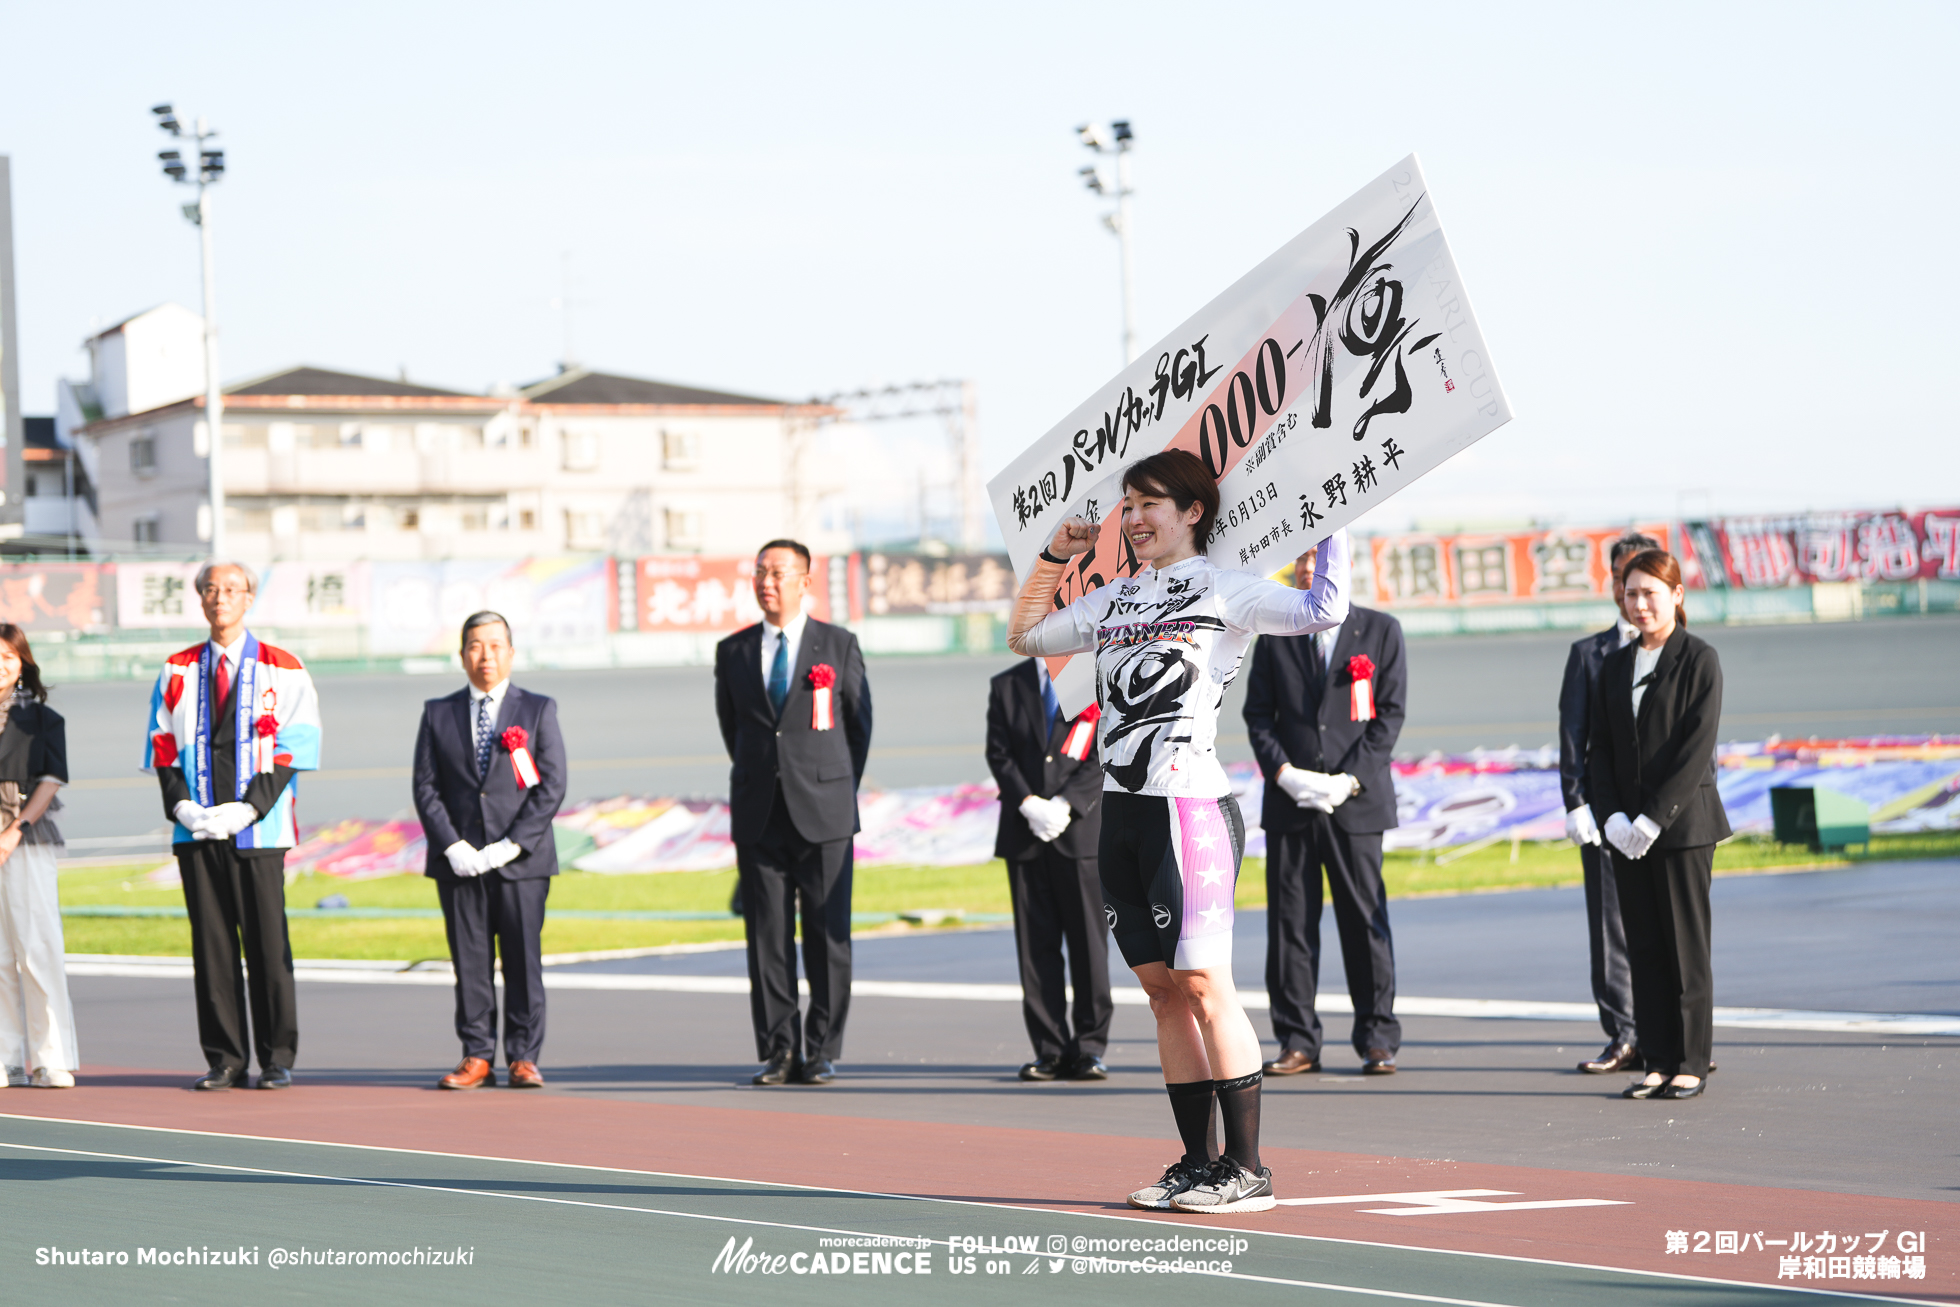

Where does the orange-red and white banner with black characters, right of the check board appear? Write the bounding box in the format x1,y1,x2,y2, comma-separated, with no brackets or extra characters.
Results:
1354,521,1674,607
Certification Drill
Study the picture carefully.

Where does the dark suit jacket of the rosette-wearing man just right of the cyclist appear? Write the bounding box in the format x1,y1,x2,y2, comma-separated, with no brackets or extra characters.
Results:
1245,607,1409,835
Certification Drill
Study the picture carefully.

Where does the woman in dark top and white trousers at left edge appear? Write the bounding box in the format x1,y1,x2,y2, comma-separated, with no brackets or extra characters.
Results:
0,621,80,1089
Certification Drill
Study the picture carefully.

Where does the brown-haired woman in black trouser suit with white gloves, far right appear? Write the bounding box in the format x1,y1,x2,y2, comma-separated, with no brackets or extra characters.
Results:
1588,549,1729,1099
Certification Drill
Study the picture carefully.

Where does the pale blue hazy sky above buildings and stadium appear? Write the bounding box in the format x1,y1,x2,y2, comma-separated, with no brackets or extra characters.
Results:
0,0,1960,527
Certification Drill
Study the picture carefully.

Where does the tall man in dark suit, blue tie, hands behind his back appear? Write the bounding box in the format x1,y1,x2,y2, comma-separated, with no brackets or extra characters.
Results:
715,541,870,1086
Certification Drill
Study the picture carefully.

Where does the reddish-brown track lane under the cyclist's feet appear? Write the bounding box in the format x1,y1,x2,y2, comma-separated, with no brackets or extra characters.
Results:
0,1068,1960,1301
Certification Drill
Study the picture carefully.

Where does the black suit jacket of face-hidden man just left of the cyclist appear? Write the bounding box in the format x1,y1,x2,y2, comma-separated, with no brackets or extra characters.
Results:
986,658,1102,862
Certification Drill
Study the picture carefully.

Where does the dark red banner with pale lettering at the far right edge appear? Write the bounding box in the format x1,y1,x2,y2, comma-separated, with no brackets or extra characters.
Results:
1686,508,1960,590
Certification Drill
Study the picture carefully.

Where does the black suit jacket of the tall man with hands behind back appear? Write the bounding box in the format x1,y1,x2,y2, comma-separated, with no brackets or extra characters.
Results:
715,617,870,845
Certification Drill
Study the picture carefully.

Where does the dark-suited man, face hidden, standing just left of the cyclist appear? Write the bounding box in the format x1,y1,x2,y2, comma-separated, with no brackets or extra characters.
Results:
986,658,1115,1080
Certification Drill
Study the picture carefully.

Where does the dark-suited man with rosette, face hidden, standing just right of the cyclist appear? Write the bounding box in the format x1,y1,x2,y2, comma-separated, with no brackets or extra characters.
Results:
1245,607,1407,1076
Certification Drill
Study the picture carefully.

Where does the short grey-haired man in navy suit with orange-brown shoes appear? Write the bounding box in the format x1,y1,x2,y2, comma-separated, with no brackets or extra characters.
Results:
416,613,564,1089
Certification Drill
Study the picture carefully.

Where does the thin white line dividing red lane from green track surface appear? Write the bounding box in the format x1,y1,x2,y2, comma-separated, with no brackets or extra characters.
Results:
0,1113,1931,1307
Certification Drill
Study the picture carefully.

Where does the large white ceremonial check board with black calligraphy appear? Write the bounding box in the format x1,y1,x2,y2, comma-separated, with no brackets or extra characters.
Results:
988,155,1511,713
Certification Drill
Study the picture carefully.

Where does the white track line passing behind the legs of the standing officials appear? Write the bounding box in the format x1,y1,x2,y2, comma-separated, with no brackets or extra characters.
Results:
53,954,1960,1037
